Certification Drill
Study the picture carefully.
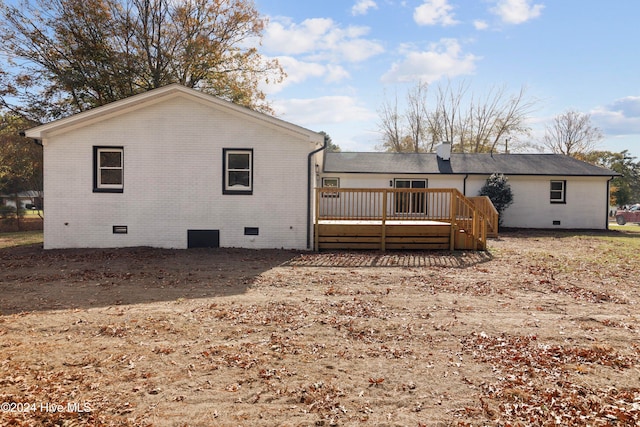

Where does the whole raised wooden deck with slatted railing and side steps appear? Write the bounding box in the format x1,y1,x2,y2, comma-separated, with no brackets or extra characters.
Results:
315,188,497,251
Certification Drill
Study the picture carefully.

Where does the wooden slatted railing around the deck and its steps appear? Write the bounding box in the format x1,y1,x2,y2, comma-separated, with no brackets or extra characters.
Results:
316,188,497,249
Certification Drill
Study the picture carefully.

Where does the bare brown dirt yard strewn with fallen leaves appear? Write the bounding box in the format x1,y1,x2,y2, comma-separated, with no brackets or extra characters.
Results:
0,232,640,427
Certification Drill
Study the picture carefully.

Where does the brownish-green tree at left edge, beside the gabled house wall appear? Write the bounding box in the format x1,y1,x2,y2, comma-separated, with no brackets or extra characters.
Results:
0,114,42,229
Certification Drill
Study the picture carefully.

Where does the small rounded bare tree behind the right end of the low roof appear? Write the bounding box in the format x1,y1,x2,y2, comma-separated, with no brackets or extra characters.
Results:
543,110,604,157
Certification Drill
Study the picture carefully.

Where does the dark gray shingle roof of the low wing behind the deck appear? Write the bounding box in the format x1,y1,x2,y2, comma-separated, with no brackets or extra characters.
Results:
324,152,619,176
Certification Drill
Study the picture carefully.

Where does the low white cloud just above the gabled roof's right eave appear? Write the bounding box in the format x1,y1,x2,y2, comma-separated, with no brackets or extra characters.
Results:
273,96,377,130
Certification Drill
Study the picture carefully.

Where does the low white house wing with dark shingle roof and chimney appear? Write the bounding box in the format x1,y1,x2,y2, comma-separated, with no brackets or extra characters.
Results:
321,144,618,229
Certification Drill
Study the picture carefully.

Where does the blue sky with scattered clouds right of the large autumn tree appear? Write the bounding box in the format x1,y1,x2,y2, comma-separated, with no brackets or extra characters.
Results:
255,0,640,158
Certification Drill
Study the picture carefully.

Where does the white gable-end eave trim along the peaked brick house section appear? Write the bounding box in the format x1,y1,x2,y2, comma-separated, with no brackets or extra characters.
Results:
25,84,324,143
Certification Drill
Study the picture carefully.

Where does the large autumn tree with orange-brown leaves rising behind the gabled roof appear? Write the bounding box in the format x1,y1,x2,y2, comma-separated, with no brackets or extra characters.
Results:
0,0,284,121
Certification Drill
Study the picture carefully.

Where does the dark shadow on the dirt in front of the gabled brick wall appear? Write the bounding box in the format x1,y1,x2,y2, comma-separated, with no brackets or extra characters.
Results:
0,245,300,315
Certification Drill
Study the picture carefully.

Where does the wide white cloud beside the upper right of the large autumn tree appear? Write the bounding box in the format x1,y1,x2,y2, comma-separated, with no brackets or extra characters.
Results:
263,18,384,62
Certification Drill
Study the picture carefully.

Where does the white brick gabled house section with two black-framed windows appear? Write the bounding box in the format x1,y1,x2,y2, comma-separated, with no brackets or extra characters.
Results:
25,85,324,249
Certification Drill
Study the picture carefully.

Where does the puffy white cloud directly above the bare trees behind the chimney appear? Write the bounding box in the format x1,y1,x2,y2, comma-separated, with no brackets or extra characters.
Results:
382,39,480,83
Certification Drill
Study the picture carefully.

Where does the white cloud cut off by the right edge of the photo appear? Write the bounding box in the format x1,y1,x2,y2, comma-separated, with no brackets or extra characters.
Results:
591,96,640,136
